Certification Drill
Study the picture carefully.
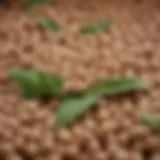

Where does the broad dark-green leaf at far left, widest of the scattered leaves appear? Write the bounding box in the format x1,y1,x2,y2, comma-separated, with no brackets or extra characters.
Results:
9,70,63,99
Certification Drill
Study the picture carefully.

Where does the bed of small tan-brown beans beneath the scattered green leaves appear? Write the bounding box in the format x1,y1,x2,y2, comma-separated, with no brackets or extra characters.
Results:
0,0,160,160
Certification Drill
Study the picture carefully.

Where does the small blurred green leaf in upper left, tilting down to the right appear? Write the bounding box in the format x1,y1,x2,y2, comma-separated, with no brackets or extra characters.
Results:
37,17,61,32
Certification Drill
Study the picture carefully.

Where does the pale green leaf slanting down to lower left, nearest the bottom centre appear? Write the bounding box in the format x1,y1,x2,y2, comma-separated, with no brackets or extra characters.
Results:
56,95,101,127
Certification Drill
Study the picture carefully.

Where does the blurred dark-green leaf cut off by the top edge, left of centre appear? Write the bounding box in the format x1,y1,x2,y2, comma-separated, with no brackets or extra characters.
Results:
24,0,54,10
